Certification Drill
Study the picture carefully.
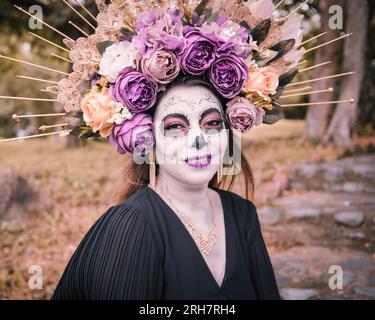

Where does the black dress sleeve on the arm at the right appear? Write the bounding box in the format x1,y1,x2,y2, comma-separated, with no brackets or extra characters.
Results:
246,201,280,300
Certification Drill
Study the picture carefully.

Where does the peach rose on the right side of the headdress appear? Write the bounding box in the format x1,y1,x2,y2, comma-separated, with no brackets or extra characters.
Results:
242,67,279,97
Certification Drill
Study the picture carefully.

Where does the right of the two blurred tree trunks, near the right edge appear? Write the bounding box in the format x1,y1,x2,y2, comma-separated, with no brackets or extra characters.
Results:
324,0,368,147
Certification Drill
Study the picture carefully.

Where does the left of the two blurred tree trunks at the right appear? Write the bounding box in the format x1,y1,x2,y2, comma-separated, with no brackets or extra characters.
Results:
306,0,342,143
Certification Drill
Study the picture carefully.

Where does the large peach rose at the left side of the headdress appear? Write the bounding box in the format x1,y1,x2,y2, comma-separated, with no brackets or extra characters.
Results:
81,90,122,137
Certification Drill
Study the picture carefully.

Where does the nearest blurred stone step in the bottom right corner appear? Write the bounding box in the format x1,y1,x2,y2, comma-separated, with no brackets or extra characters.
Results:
270,245,375,300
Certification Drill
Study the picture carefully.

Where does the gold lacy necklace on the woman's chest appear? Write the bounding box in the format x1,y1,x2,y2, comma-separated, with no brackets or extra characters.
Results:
159,186,218,255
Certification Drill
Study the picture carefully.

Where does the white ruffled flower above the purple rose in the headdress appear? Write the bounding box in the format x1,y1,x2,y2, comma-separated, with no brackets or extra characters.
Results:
99,41,138,82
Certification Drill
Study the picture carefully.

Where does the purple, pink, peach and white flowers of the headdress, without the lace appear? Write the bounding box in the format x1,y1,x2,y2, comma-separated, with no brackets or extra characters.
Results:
74,1,302,154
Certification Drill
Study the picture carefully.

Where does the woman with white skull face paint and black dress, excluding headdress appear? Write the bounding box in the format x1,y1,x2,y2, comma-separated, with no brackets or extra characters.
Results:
52,77,279,299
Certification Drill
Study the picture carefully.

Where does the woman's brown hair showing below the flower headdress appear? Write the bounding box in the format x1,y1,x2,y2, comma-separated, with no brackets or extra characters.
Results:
109,76,254,203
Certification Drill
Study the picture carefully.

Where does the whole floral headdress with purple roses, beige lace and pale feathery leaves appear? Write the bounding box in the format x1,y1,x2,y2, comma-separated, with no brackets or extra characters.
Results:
0,0,352,154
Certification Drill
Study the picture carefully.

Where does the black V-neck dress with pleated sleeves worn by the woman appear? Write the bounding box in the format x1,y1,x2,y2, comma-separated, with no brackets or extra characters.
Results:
52,186,280,300
